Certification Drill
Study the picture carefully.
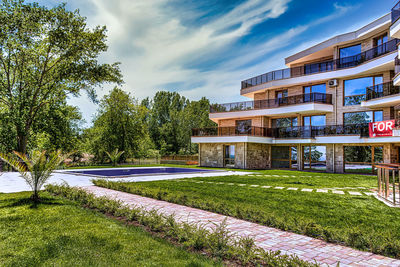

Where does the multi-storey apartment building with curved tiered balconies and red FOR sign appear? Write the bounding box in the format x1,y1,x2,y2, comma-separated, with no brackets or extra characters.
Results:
192,4,400,173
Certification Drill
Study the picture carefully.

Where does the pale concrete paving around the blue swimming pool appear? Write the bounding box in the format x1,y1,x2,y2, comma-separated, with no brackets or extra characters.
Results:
0,167,244,193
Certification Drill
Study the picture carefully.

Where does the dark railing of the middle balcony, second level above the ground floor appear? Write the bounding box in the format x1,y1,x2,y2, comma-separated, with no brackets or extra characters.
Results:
210,93,332,113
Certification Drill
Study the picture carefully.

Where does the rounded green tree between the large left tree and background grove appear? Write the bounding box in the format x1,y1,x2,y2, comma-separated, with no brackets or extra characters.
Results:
85,88,149,161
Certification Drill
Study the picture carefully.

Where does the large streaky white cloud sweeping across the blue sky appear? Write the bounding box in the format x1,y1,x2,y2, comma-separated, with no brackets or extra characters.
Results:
65,0,356,122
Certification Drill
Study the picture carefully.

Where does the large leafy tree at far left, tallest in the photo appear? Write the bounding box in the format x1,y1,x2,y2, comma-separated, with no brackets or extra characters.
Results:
0,0,122,153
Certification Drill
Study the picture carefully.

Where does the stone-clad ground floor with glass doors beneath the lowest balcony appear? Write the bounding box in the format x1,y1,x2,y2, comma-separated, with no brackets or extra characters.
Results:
199,142,400,173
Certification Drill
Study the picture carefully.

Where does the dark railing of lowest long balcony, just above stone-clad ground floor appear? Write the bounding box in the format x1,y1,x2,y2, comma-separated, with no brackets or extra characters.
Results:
192,123,369,139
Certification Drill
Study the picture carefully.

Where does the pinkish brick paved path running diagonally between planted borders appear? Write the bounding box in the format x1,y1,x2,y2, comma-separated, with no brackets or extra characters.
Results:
85,186,400,266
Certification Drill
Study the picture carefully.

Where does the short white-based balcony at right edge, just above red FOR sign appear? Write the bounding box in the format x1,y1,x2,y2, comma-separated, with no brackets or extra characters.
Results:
361,82,400,108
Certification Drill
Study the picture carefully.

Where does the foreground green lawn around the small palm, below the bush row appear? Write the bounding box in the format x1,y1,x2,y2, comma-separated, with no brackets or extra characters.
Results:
0,193,219,266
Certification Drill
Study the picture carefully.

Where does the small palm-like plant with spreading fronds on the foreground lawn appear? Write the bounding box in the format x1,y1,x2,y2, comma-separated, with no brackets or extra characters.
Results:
0,151,65,202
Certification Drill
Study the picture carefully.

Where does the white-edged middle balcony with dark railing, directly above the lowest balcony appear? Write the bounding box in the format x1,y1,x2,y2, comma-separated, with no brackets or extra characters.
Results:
210,93,333,121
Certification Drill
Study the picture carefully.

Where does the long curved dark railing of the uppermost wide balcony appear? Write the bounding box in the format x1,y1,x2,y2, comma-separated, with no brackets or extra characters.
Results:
242,39,399,89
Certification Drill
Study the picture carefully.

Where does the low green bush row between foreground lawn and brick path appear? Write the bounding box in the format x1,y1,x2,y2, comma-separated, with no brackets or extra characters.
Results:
46,185,318,266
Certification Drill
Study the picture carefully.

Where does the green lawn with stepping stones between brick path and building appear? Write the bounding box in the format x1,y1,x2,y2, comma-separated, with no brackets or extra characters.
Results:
97,171,400,258
